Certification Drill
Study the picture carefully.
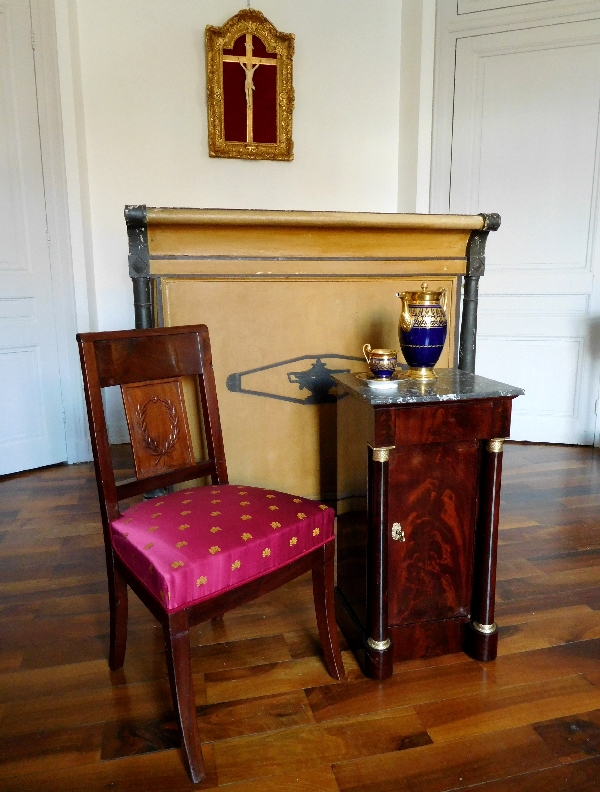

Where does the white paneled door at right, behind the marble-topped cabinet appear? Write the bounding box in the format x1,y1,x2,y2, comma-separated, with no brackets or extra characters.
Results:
450,20,600,445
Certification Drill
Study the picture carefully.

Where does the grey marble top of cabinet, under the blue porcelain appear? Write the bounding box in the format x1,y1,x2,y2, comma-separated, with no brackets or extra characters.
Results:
333,368,525,405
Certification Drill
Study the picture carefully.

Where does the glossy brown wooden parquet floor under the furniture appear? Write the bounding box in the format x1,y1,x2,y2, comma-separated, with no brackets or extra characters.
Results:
0,444,600,792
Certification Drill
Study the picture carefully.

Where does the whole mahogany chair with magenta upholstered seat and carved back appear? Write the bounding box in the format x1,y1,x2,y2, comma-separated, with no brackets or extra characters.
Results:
77,325,344,783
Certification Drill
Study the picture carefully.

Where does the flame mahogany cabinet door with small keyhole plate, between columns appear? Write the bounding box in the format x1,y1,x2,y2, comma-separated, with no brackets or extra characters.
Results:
388,440,479,625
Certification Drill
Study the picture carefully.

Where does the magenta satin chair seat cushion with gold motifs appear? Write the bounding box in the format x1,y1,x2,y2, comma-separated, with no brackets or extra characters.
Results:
111,484,334,612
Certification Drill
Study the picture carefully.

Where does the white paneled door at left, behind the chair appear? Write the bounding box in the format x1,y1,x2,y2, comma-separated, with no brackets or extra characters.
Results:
0,0,67,475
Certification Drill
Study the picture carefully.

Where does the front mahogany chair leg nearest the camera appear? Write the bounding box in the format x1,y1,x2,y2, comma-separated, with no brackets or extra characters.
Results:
163,611,206,784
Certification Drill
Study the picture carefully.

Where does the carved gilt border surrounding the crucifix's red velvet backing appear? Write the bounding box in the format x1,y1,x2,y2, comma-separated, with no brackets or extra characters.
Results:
206,8,294,160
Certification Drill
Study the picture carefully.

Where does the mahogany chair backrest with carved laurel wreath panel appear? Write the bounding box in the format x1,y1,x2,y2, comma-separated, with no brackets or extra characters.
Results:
77,325,227,529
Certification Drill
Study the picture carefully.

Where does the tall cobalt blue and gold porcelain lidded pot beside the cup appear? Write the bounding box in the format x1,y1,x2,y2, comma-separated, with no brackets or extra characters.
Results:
396,283,448,382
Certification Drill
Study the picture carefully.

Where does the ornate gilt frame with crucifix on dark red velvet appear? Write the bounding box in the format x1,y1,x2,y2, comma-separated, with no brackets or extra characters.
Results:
206,8,294,160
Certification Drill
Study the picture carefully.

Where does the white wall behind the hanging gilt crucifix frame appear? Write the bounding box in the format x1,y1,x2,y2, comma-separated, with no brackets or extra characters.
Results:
55,0,435,434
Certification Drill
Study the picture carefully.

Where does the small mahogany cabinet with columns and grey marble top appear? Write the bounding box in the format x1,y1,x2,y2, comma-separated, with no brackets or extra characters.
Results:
335,369,523,679
